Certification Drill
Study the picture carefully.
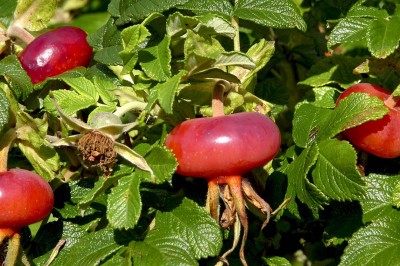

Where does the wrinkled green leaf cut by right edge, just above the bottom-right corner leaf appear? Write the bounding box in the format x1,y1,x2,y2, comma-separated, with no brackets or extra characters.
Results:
360,174,400,223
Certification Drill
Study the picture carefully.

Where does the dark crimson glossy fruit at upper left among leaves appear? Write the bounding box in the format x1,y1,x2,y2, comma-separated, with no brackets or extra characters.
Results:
19,26,93,84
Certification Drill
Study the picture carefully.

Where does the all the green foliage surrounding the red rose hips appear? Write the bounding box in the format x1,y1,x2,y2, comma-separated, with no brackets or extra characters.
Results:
0,0,400,266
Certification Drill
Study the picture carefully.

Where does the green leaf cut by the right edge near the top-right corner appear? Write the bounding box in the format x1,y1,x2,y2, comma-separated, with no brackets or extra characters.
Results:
367,16,400,58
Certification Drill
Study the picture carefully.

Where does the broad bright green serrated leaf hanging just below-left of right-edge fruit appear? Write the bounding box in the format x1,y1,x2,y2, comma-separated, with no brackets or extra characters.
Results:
312,139,366,201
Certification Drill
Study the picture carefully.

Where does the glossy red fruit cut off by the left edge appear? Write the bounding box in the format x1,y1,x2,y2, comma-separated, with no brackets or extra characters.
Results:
0,169,54,233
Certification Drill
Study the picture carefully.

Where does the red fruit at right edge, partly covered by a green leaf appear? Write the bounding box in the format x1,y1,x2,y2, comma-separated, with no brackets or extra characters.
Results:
337,83,400,158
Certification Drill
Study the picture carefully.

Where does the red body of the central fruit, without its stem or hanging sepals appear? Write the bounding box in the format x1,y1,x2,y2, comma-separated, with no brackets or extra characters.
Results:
165,112,281,178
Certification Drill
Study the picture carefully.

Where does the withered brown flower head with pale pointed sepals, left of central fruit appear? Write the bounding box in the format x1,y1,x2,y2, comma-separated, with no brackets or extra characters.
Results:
48,98,153,176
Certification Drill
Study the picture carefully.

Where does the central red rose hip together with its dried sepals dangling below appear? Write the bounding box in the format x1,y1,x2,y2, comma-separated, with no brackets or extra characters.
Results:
165,112,281,265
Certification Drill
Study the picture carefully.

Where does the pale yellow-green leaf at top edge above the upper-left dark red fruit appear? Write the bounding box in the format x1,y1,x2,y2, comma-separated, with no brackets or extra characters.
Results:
14,0,57,31
